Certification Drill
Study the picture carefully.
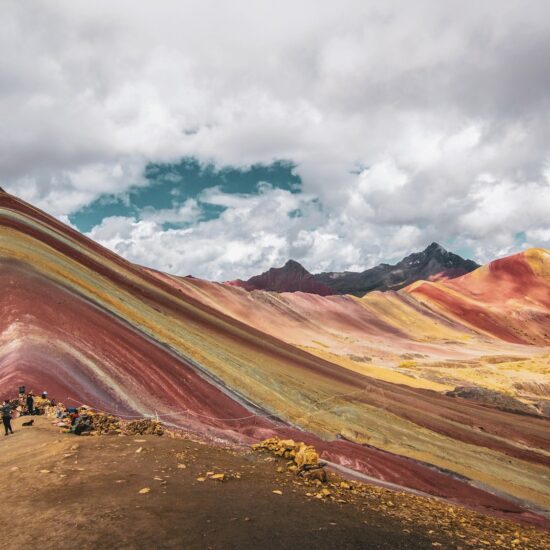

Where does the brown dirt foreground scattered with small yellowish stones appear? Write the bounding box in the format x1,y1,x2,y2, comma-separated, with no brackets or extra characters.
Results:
0,417,550,549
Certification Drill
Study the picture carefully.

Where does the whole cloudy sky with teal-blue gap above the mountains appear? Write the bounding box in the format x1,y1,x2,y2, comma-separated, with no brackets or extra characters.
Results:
0,0,550,280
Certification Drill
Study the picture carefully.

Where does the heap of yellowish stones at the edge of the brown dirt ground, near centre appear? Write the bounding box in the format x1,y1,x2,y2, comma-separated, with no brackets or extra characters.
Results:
252,437,327,483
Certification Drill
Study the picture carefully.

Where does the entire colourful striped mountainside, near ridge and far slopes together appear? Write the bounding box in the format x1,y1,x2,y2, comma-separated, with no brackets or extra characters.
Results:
0,192,550,526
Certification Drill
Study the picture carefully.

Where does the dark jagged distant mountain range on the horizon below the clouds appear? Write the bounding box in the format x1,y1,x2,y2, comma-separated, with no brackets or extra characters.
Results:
227,243,479,296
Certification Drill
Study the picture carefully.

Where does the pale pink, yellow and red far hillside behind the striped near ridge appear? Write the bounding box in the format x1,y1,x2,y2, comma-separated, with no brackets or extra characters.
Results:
178,251,550,402
